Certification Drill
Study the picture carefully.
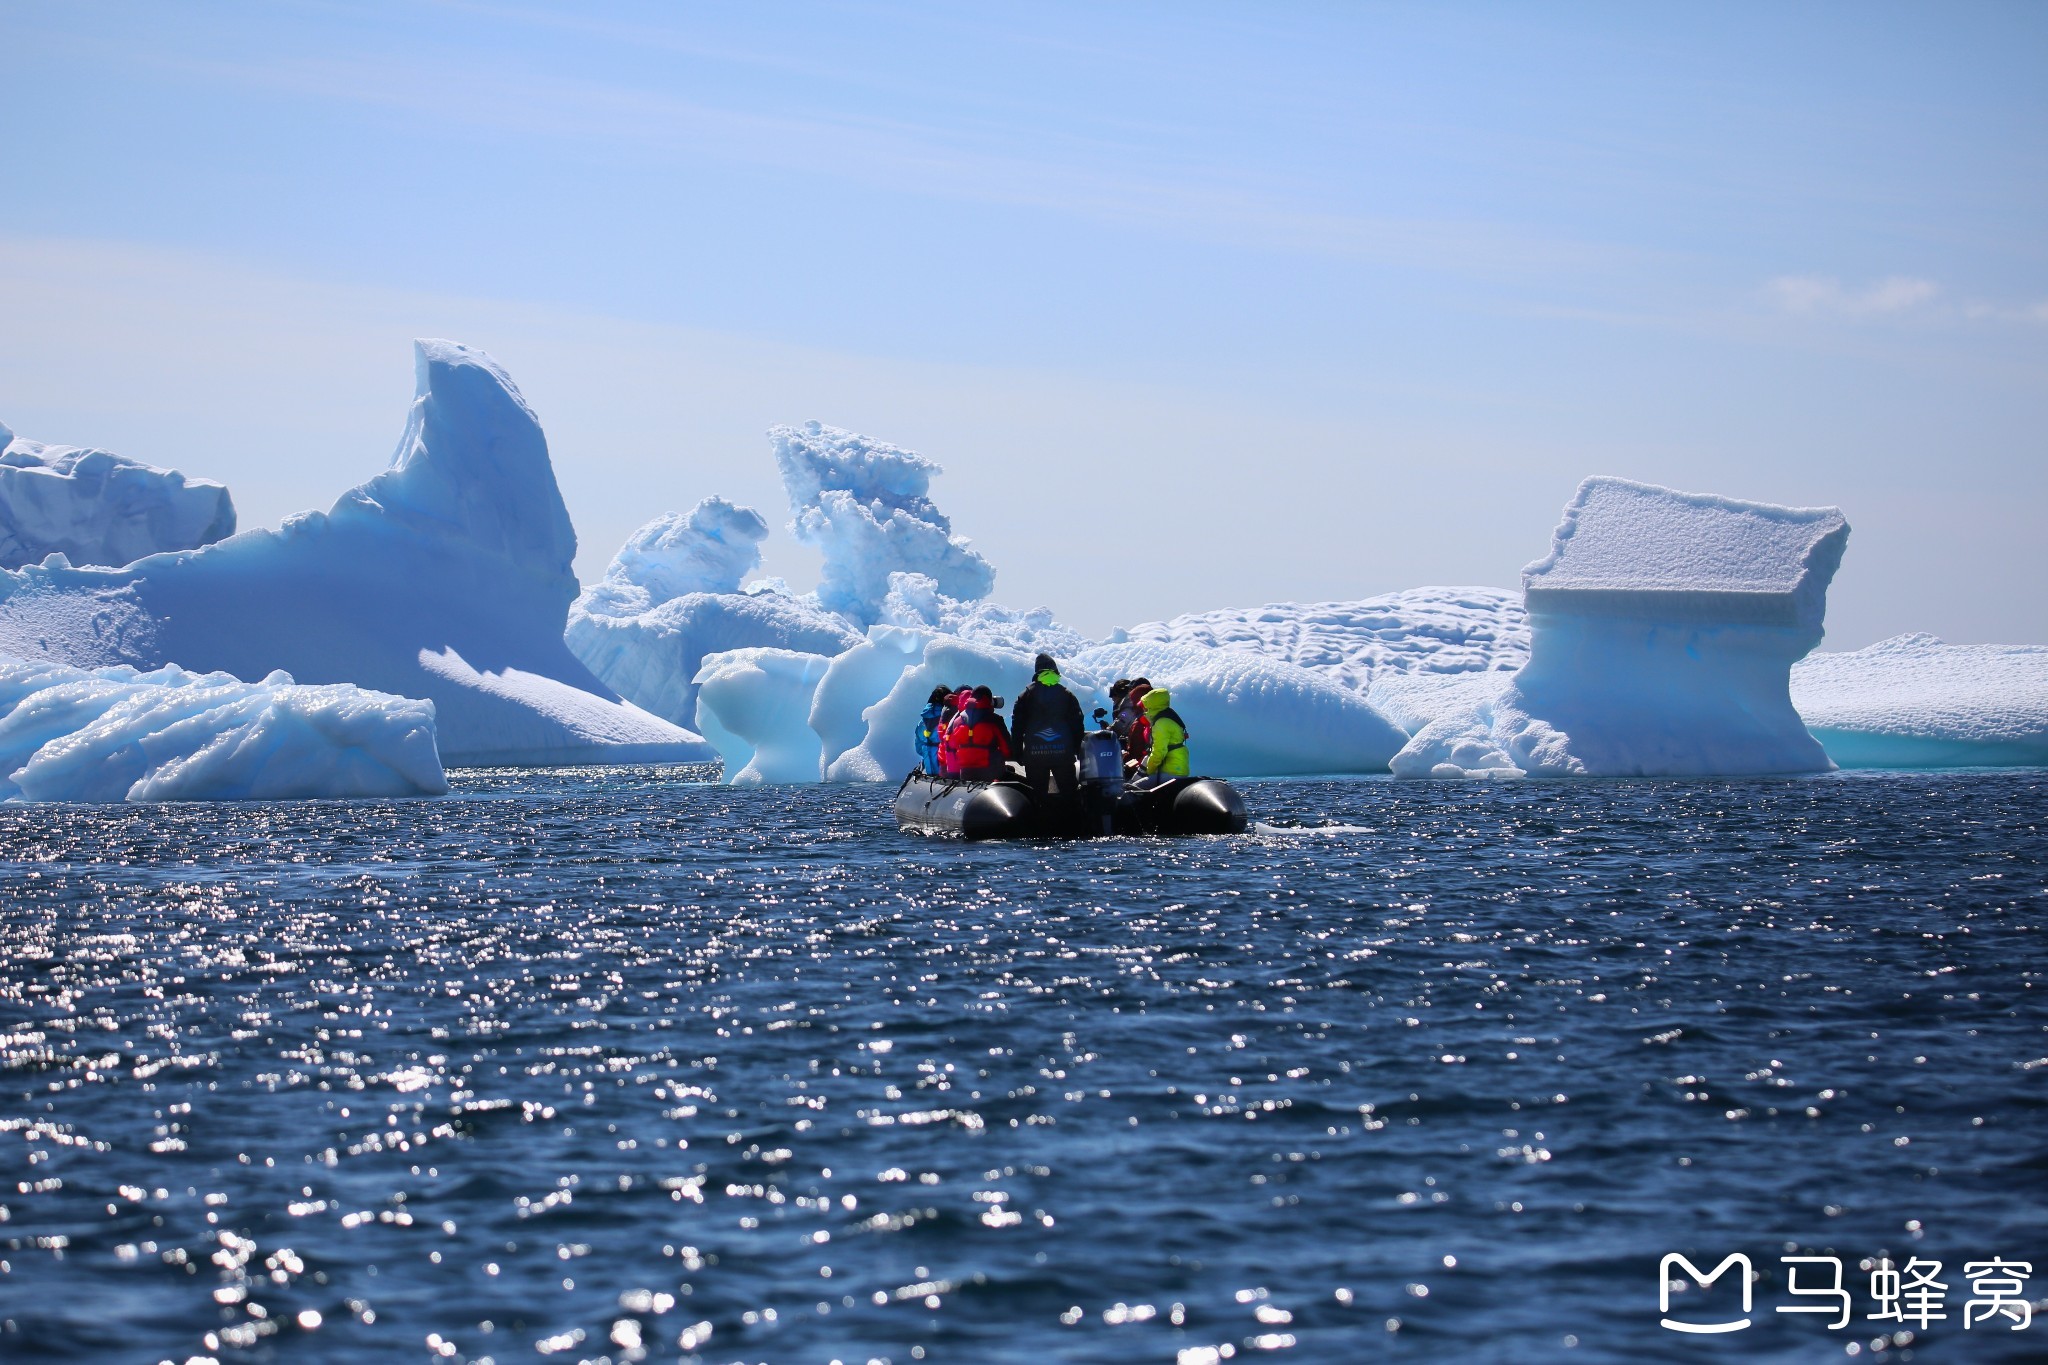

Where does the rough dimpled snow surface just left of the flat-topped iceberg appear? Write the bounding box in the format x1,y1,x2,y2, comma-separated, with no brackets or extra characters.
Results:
1128,587,1530,690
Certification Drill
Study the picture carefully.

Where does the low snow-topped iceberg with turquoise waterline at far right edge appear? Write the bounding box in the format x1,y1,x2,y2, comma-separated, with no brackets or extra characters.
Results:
1792,634,2048,767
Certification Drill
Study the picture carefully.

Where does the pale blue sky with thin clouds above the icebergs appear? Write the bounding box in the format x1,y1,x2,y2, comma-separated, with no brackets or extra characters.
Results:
0,0,2048,647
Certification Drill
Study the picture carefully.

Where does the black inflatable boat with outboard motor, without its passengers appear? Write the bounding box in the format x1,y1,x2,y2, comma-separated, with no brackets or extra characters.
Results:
895,731,1247,839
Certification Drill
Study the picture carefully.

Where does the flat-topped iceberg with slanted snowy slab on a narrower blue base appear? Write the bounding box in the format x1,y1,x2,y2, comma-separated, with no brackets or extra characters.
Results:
1393,477,1849,778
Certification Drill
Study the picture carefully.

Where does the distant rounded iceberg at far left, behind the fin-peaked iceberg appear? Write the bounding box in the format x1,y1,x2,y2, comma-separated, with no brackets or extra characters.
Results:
0,426,236,569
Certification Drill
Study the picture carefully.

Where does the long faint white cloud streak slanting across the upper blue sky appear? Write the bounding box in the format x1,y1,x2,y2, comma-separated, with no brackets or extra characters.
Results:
136,55,1661,276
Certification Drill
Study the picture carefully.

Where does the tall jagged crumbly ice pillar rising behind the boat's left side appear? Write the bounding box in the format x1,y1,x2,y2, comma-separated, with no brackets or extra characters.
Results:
768,422,995,626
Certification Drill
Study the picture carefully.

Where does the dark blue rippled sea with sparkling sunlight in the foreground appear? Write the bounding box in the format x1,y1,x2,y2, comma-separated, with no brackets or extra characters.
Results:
0,769,2048,1365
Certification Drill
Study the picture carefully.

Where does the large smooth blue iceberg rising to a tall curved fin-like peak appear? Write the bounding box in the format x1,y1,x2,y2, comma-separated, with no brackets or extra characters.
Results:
0,342,713,763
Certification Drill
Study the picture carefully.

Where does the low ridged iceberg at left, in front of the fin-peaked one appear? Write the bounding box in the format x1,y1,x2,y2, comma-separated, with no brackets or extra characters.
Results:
0,659,449,802
